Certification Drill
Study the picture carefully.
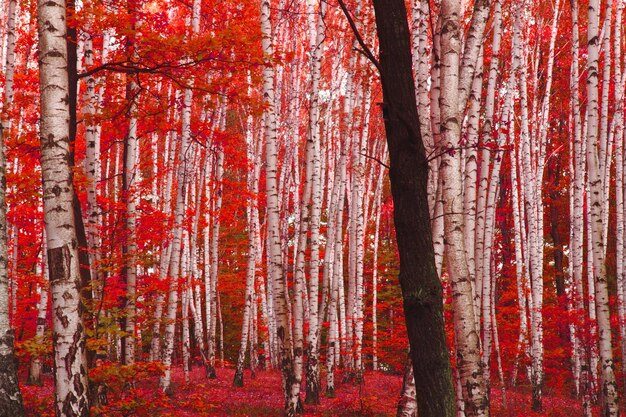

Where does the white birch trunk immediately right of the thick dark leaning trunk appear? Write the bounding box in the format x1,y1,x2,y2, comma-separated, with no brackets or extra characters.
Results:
439,0,489,416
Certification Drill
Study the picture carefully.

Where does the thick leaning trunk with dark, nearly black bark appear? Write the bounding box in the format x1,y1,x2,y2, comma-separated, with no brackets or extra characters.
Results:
374,0,455,417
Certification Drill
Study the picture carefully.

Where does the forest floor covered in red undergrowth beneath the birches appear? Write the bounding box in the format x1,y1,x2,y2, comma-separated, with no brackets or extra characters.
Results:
22,368,597,417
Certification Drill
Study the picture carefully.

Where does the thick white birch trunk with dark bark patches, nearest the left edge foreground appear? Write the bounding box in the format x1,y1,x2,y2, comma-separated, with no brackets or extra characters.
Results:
38,0,89,417
